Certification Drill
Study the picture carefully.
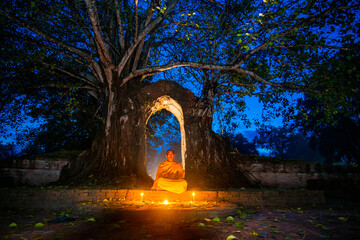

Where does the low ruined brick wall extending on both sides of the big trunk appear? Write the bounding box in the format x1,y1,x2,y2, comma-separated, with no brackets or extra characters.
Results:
0,156,360,189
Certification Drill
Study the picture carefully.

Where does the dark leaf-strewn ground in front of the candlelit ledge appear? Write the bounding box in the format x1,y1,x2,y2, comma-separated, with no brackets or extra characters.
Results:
0,200,360,240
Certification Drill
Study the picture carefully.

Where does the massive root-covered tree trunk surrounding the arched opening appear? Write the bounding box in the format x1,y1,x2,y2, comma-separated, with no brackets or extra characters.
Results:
62,81,247,188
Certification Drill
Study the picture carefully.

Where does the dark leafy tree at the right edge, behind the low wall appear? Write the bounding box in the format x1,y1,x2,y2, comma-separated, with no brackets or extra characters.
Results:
296,52,360,165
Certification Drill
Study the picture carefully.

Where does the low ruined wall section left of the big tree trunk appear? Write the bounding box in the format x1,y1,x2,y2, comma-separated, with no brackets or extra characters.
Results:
0,158,69,186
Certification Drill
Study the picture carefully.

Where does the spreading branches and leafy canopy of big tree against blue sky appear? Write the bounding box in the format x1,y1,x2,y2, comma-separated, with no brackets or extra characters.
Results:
0,0,360,165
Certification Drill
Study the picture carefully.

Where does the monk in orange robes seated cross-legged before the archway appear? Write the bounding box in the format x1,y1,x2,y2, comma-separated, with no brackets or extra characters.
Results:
151,149,187,194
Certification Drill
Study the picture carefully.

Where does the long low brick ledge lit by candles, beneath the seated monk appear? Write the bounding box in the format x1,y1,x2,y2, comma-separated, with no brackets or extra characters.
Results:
0,188,326,208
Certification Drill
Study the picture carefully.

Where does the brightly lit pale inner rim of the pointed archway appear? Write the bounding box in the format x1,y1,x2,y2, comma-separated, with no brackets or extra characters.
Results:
145,95,186,169
